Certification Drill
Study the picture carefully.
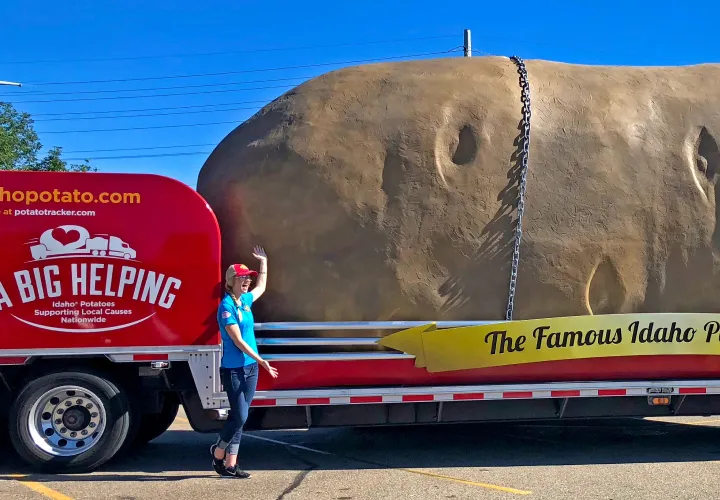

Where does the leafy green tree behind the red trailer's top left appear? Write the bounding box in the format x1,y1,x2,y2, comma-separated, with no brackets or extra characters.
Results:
0,102,96,172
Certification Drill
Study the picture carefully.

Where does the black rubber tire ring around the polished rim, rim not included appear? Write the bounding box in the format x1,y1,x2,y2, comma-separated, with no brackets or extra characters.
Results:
10,371,131,472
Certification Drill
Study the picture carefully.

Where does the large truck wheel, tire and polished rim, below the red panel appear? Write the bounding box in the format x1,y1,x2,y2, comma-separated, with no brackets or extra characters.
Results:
10,372,130,472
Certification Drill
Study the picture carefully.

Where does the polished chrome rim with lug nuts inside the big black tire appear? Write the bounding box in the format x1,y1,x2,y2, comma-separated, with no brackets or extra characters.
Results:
28,385,107,457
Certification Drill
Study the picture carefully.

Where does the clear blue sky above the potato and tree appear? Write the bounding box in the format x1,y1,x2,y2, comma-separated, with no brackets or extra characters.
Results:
0,0,720,187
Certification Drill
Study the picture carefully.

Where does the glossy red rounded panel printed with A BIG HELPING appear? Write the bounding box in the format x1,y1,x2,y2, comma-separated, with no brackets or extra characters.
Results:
0,172,221,355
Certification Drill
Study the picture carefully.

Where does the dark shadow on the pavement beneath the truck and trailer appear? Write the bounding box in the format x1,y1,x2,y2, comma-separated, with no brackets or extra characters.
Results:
0,419,720,482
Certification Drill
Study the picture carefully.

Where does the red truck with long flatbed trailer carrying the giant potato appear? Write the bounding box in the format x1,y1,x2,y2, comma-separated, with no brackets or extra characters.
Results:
0,172,720,471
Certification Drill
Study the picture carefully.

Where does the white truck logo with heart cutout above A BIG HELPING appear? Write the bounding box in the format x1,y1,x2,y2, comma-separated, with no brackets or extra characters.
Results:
28,224,137,260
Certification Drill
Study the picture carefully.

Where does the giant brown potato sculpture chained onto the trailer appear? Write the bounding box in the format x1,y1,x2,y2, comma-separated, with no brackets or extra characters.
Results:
198,57,720,321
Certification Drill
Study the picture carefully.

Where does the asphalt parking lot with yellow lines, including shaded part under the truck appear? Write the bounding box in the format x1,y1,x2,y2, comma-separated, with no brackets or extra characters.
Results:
0,410,720,500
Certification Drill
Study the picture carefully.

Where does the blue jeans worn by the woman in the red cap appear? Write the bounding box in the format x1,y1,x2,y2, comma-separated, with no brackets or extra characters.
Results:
217,363,258,455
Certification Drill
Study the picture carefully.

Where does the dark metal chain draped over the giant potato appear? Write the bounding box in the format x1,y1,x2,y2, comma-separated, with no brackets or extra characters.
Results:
505,56,531,321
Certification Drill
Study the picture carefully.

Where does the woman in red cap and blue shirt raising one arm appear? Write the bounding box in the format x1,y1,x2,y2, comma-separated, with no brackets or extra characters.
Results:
210,247,278,479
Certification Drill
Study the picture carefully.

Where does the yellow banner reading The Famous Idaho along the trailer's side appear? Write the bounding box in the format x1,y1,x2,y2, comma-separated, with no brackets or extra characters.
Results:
378,313,720,373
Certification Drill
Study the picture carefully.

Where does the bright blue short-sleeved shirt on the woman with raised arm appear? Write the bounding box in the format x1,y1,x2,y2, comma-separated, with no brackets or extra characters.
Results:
217,292,257,368
